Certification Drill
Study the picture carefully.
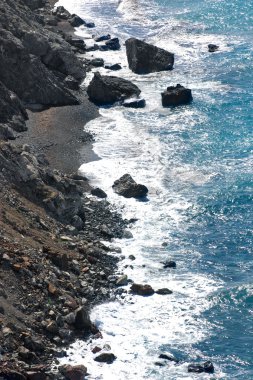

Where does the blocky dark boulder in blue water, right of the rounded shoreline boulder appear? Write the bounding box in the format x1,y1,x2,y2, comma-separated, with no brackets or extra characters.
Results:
161,84,192,107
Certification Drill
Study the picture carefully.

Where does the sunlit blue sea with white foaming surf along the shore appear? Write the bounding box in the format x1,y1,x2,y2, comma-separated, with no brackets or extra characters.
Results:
56,0,253,380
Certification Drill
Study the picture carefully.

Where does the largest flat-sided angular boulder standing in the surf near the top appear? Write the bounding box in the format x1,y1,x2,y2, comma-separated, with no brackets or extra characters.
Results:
126,38,174,74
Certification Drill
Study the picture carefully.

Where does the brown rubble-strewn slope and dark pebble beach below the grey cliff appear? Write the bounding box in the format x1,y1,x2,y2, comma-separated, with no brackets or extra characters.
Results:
0,0,125,379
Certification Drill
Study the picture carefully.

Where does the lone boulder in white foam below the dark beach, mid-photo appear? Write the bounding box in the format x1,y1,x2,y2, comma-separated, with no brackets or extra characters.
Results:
112,174,148,198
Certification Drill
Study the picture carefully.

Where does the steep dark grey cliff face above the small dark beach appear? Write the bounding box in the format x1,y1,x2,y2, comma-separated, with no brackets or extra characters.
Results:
0,0,85,139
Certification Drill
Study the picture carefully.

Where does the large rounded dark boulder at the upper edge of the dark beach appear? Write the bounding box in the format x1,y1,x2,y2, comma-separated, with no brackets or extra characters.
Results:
87,72,141,105
